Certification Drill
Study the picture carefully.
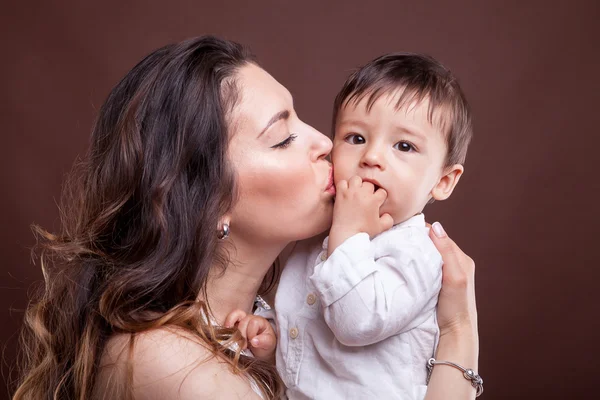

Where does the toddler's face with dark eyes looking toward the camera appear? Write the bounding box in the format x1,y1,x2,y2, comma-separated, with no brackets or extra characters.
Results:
332,93,453,223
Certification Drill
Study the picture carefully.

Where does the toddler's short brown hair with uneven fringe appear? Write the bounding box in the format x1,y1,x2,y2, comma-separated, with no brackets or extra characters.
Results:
333,53,473,166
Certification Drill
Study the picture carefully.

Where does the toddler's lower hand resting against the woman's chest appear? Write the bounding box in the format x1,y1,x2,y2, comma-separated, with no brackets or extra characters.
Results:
225,310,277,363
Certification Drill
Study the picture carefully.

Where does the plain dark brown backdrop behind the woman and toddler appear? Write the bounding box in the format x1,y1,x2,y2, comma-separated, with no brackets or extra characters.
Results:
0,0,600,400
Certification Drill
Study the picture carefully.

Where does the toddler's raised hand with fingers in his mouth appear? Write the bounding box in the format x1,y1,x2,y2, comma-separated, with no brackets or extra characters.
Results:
327,176,394,256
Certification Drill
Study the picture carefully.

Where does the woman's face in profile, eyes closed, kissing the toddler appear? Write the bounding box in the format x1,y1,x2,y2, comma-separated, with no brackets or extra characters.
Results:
229,64,335,244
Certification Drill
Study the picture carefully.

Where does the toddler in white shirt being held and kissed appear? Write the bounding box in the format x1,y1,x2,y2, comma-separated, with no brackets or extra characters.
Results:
227,53,472,399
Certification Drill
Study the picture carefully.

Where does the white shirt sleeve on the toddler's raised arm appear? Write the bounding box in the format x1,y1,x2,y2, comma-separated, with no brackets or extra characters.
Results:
310,229,442,346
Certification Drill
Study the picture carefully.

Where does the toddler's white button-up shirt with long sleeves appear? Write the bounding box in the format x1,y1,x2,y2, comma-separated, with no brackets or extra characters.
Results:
275,214,442,399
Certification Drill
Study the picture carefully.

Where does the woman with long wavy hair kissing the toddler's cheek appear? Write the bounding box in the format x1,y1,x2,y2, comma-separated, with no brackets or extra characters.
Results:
14,37,478,399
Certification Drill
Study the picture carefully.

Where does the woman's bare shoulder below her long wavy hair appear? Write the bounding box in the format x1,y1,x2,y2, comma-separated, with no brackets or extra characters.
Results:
97,328,259,400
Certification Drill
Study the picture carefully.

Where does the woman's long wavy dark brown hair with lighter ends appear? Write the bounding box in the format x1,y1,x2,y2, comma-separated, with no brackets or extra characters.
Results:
14,36,283,400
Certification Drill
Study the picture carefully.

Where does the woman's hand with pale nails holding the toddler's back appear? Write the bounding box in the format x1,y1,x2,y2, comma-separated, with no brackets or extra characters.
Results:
429,222,477,339
